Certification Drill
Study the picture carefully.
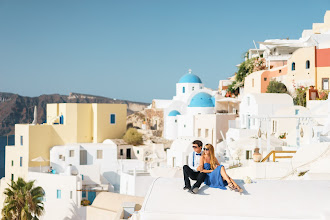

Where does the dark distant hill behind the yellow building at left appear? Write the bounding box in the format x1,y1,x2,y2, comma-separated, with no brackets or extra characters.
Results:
0,92,149,136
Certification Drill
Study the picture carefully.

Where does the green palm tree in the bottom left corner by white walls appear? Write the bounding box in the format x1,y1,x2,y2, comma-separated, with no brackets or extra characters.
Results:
2,177,45,220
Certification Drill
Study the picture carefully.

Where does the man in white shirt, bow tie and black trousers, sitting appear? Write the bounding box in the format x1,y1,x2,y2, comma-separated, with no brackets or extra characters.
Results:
183,140,206,194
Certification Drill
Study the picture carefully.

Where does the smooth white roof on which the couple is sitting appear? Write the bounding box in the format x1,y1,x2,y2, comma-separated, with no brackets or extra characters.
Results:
140,178,330,220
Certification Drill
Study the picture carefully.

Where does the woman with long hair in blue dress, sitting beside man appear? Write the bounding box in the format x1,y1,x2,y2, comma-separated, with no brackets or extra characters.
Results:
197,144,243,193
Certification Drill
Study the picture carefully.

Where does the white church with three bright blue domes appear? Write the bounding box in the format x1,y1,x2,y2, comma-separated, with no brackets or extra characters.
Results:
155,70,217,140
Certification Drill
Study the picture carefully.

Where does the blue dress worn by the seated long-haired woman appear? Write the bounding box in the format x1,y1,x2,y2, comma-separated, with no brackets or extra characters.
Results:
204,163,228,190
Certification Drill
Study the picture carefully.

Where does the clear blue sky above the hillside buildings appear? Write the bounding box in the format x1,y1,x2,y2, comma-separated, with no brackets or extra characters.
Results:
0,0,330,102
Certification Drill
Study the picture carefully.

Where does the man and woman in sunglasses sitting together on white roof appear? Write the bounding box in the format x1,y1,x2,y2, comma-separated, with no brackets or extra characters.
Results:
183,140,243,194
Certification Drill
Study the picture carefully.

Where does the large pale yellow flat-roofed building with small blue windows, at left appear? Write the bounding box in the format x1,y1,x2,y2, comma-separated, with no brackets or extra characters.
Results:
5,103,127,182
